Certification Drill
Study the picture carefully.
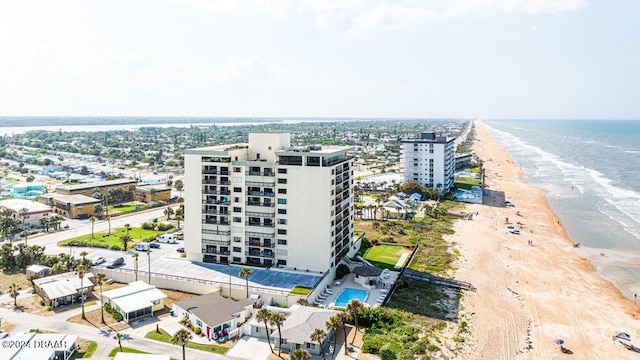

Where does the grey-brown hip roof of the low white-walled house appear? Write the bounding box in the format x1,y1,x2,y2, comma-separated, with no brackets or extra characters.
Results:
176,292,253,326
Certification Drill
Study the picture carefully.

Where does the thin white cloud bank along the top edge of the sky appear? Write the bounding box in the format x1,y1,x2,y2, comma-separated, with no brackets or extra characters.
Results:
173,0,588,37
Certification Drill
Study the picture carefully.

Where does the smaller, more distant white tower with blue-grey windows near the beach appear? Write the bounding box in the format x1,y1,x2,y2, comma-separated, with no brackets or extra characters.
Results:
402,132,455,192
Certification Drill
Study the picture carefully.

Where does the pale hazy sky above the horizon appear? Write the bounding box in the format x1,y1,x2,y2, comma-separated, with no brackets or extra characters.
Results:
0,0,640,119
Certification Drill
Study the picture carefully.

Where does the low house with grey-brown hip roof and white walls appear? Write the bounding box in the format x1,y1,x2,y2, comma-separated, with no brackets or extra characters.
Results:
173,292,253,340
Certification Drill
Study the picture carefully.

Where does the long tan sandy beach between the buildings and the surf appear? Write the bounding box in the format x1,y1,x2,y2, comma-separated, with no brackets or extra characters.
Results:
450,123,640,359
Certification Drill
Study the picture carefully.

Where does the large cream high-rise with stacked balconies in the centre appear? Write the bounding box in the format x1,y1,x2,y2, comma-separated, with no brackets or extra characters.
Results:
184,133,357,272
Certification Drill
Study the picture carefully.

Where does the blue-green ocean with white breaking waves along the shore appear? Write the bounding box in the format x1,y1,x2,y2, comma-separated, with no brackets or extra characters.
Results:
481,120,640,299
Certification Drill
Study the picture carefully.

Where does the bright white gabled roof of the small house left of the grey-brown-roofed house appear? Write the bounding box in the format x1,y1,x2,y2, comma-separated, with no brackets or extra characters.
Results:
102,281,167,312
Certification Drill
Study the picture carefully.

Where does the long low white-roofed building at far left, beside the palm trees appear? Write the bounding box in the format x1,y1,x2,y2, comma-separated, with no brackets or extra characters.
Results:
33,271,93,308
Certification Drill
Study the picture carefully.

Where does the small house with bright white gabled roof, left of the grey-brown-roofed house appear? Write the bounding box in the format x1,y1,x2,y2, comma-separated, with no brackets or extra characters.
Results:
102,281,167,322
